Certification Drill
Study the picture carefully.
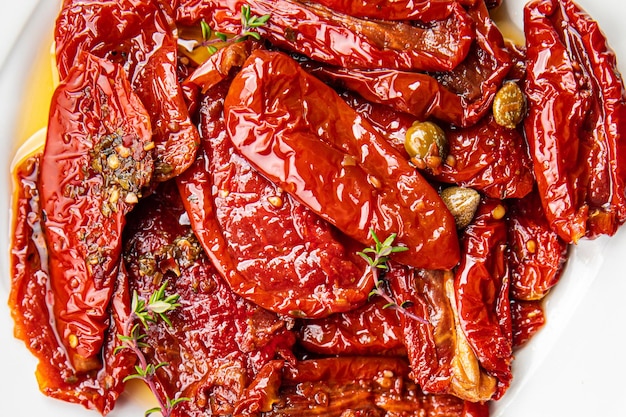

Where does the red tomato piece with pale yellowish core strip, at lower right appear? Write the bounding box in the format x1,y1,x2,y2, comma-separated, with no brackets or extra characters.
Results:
387,267,496,402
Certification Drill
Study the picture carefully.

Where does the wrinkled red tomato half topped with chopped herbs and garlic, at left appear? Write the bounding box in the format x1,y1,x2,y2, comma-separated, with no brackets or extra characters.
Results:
40,53,153,370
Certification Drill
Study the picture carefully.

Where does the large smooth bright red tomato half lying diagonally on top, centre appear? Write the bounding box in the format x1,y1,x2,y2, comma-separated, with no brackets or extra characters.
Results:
224,51,459,269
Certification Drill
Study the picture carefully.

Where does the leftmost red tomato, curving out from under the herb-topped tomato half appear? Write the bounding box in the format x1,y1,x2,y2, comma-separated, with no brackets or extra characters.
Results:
8,156,135,414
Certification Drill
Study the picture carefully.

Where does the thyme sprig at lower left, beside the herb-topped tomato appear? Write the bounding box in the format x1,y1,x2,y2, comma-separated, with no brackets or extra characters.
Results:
114,281,189,417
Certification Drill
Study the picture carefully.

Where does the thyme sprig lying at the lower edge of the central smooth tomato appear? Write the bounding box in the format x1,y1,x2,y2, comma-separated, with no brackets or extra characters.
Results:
357,229,427,323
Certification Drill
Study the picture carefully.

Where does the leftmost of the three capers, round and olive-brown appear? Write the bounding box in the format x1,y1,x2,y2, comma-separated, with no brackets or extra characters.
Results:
404,121,448,169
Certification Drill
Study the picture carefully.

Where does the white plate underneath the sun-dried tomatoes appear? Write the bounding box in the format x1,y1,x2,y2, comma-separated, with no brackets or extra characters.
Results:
0,0,626,417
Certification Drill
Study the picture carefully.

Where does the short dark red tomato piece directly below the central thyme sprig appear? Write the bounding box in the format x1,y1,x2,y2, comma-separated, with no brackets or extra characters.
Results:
297,300,406,356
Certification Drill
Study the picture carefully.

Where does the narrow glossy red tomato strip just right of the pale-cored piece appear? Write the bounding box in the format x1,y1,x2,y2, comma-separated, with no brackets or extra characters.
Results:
454,199,512,399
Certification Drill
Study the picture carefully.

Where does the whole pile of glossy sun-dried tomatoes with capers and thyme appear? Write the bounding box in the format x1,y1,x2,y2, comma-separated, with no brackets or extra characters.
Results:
9,0,626,417
